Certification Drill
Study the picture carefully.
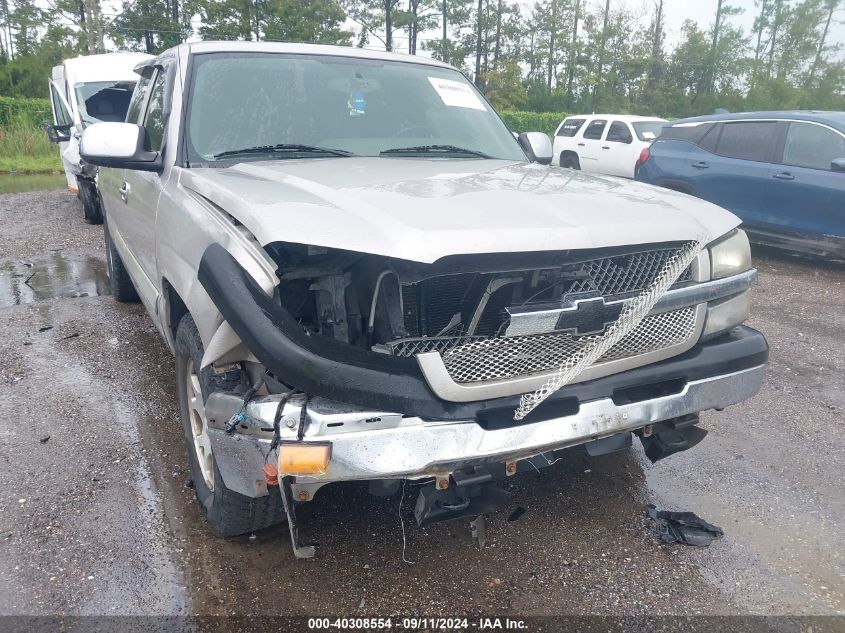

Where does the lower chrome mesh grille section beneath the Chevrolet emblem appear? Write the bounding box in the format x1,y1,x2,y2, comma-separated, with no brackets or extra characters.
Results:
436,307,696,383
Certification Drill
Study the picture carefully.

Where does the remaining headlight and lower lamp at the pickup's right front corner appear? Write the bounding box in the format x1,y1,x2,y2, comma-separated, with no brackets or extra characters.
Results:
702,229,751,340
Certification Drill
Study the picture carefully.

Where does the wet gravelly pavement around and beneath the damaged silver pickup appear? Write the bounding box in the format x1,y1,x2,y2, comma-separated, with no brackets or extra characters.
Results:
0,192,845,616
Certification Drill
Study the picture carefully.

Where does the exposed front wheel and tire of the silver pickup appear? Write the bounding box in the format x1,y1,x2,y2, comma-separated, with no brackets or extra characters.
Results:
176,314,286,536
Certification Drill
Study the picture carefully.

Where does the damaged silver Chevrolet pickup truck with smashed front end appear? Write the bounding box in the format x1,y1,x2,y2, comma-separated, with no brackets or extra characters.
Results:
81,42,768,556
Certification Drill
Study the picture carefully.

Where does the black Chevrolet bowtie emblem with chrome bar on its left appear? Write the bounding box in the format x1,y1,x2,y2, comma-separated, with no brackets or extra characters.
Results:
505,297,625,336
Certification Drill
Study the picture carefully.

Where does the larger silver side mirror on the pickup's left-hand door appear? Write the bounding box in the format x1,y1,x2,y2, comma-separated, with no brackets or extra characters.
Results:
79,122,162,172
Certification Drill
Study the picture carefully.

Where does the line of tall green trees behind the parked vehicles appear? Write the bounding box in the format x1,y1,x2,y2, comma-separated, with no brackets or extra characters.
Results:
0,0,845,117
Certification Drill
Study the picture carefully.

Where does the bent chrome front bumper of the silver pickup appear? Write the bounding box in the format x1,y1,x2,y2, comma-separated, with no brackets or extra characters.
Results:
206,365,765,497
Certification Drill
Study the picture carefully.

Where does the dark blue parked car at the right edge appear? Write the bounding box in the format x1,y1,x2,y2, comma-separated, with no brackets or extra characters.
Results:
635,112,845,258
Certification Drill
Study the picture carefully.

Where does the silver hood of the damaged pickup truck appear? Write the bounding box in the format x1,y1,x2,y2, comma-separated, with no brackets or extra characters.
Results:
180,158,740,263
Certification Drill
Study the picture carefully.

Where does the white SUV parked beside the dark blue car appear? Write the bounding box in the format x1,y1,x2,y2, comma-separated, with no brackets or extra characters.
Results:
552,114,668,178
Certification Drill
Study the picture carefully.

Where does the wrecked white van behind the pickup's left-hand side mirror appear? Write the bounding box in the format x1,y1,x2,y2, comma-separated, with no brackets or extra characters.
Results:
45,53,152,224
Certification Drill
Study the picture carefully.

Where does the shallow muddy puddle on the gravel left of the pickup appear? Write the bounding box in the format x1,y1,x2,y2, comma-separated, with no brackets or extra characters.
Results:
0,251,111,307
